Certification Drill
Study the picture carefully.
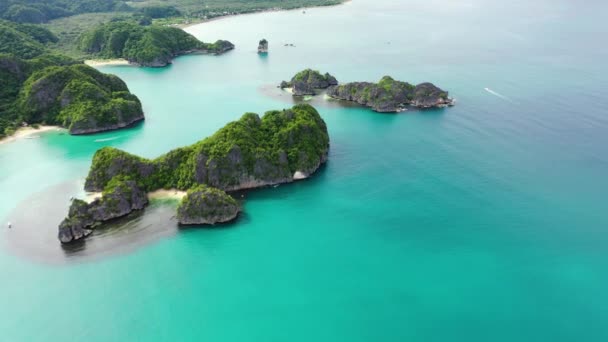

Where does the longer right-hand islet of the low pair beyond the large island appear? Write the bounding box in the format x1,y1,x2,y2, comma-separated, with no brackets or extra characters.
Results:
328,76,453,112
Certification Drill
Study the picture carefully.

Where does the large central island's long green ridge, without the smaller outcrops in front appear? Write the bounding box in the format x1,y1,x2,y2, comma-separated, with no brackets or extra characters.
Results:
85,104,329,191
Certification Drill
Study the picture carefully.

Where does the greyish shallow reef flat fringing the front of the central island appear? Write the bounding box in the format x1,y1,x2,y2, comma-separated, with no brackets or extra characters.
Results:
2,164,327,264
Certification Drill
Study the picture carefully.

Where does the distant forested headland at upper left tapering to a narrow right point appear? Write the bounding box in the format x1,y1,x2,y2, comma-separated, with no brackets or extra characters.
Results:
79,20,234,67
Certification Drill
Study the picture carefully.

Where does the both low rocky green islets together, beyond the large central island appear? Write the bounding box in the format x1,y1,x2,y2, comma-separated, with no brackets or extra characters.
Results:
279,69,454,113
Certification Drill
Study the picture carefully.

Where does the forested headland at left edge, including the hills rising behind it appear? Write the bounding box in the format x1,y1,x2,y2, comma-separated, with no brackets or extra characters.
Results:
0,21,144,138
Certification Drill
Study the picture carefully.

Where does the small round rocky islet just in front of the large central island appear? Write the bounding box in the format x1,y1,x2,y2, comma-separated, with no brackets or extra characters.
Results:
177,185,239,225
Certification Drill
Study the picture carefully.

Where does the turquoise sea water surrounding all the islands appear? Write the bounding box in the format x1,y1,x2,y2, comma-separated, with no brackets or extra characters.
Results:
0,0,608,341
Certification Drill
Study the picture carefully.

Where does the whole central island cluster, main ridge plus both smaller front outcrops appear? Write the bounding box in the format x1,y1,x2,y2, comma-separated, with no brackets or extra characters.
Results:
58,104,329,243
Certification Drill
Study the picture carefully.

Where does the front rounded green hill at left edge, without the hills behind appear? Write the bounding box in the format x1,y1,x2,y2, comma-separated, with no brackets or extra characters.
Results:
0,54,144,136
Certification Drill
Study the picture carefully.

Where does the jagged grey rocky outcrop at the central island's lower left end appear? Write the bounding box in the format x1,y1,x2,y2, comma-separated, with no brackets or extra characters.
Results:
58,177,148,243
